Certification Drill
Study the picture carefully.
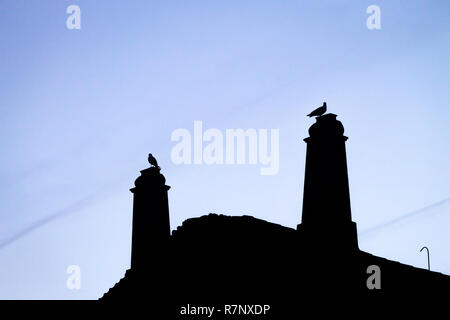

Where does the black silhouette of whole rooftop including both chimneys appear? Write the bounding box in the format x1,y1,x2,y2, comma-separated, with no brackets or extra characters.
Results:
101,114,450,319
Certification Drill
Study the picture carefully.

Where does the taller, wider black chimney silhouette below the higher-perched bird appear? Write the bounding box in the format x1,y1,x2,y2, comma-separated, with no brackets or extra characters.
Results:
297,113,358,249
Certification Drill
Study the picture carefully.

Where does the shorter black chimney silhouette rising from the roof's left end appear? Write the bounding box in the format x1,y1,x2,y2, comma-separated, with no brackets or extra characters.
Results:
130,158,170,269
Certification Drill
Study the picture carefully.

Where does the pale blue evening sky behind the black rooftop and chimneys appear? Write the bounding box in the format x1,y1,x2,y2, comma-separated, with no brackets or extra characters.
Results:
0,0,450,299
